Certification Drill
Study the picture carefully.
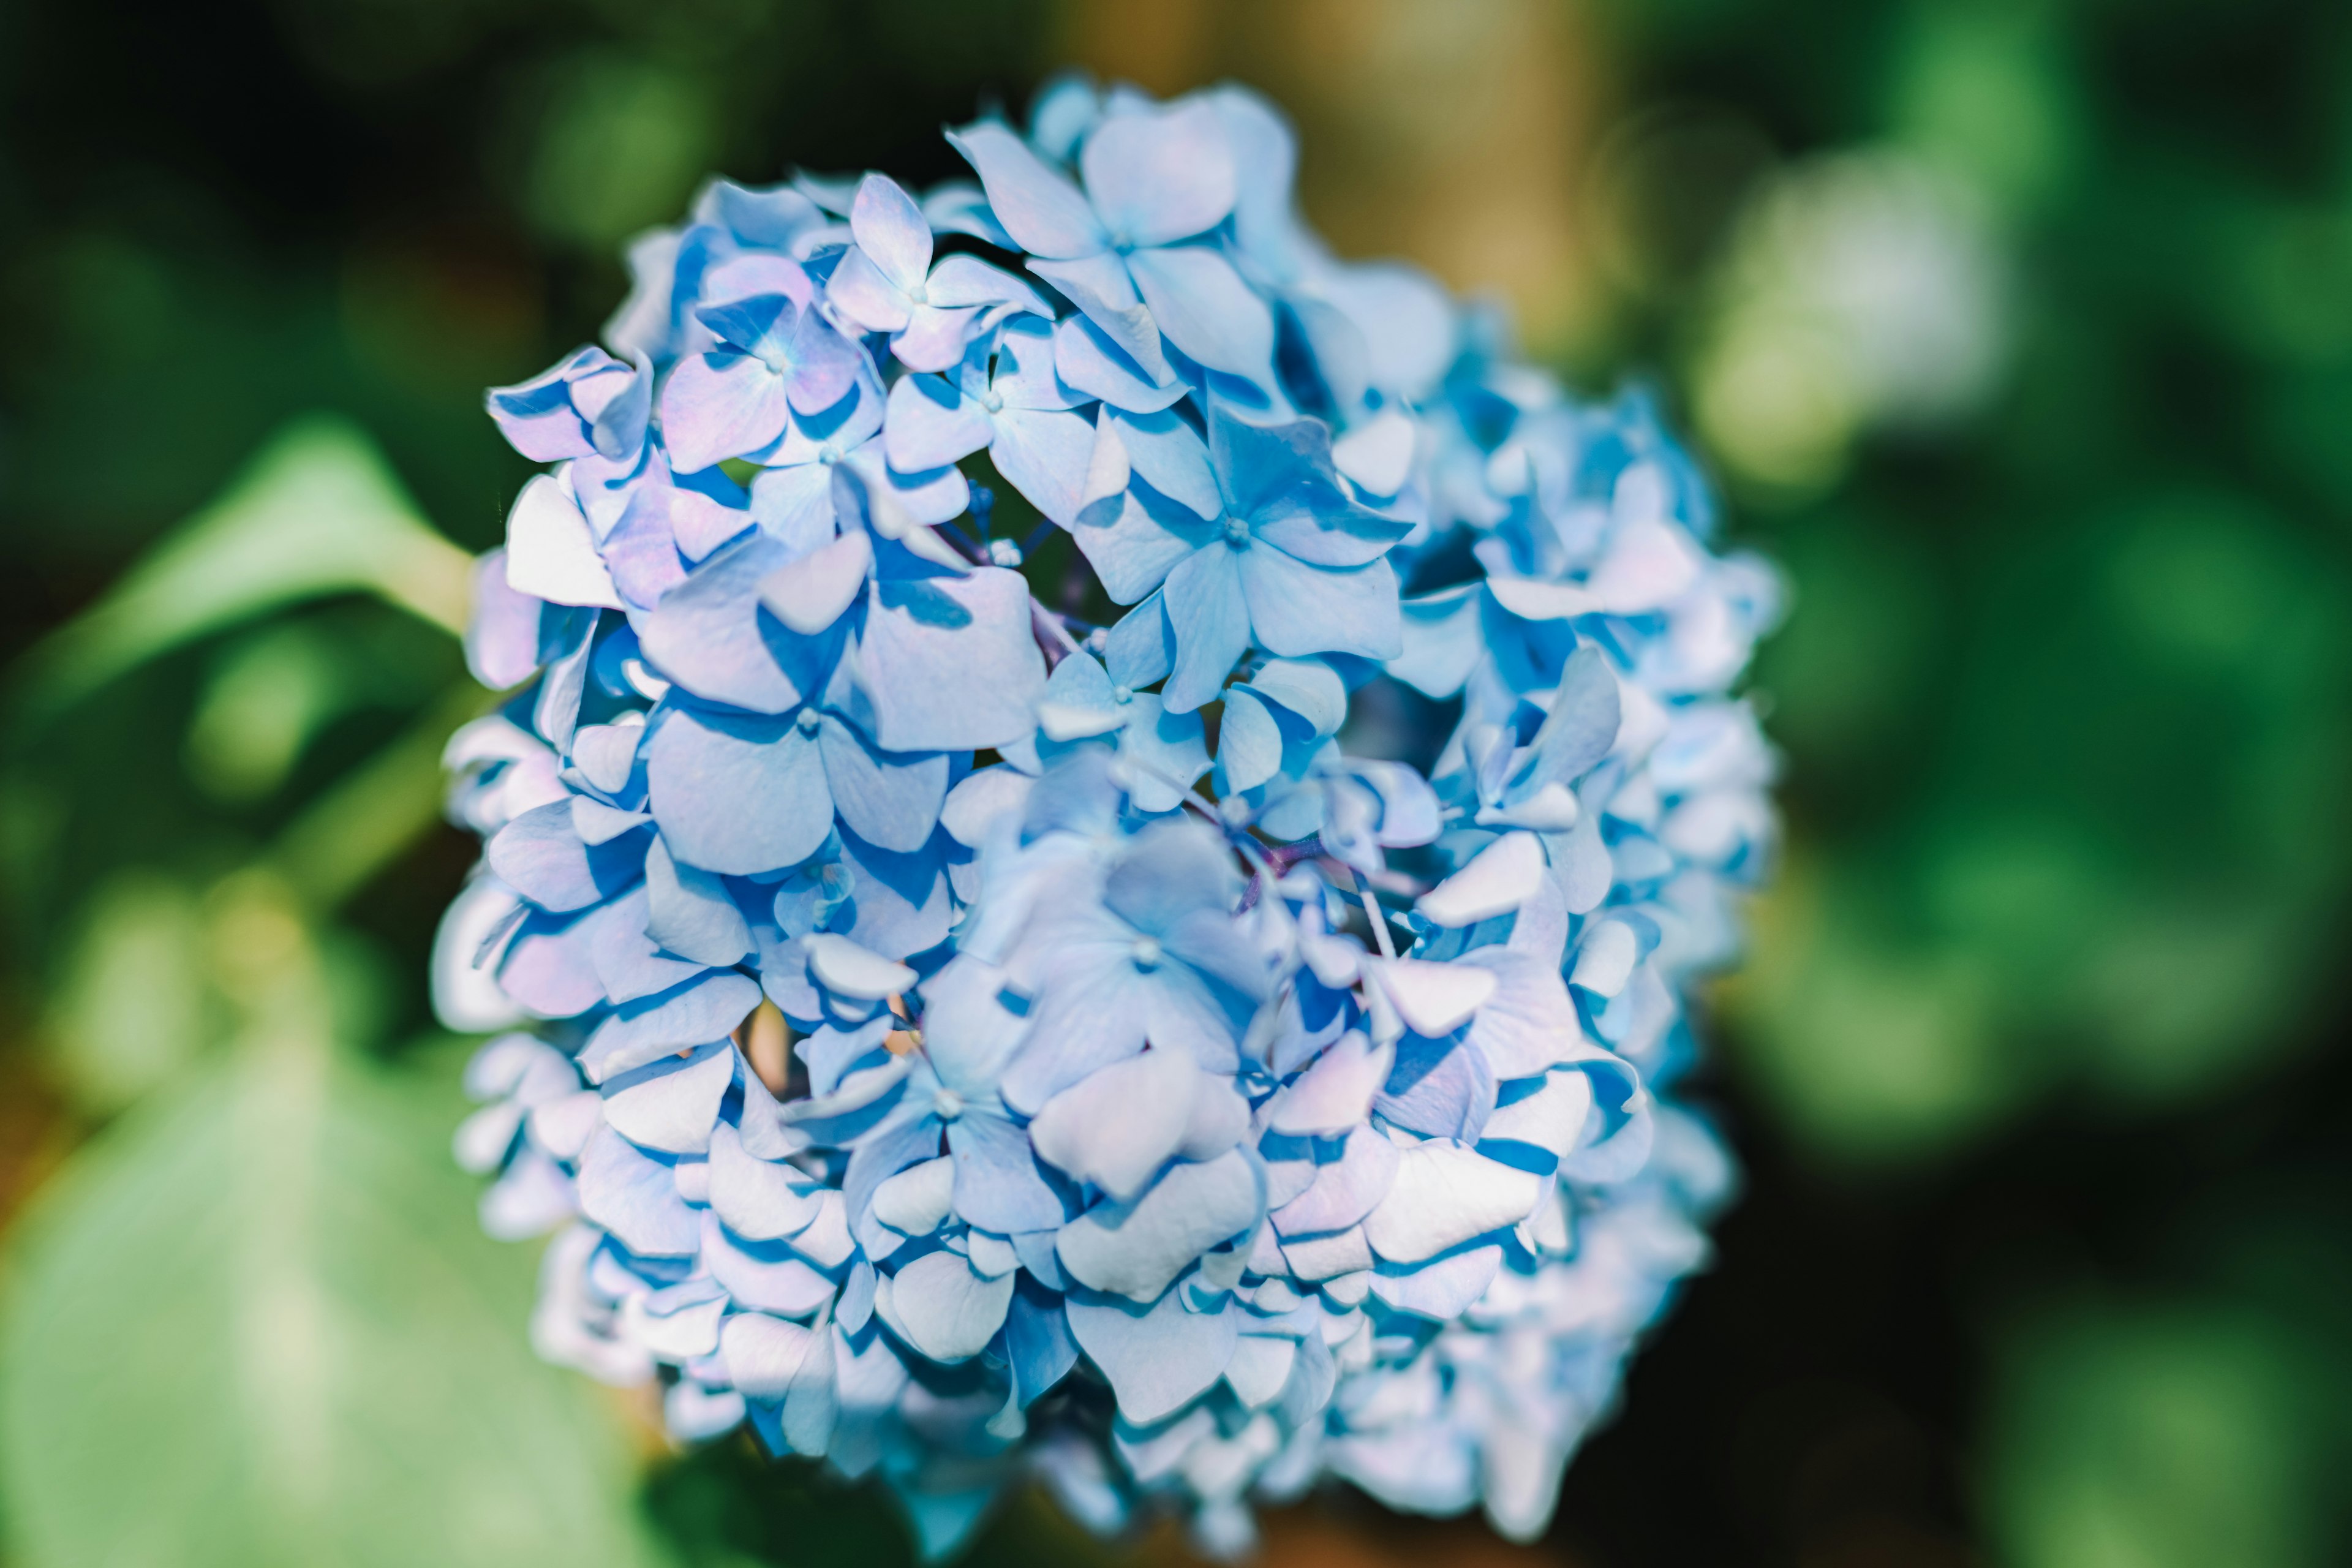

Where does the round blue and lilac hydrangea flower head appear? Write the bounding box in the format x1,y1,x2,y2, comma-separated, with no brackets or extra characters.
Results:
435,82,1773,1554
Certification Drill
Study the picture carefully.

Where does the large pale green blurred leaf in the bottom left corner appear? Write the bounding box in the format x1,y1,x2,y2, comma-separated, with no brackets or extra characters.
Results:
0,1034,673,1568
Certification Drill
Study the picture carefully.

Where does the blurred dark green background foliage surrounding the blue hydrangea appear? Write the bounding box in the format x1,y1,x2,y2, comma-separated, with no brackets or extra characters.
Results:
0,0,2352,1568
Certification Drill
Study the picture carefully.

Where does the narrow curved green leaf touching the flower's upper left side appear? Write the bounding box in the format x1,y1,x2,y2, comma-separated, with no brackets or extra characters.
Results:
23,414,473,710
